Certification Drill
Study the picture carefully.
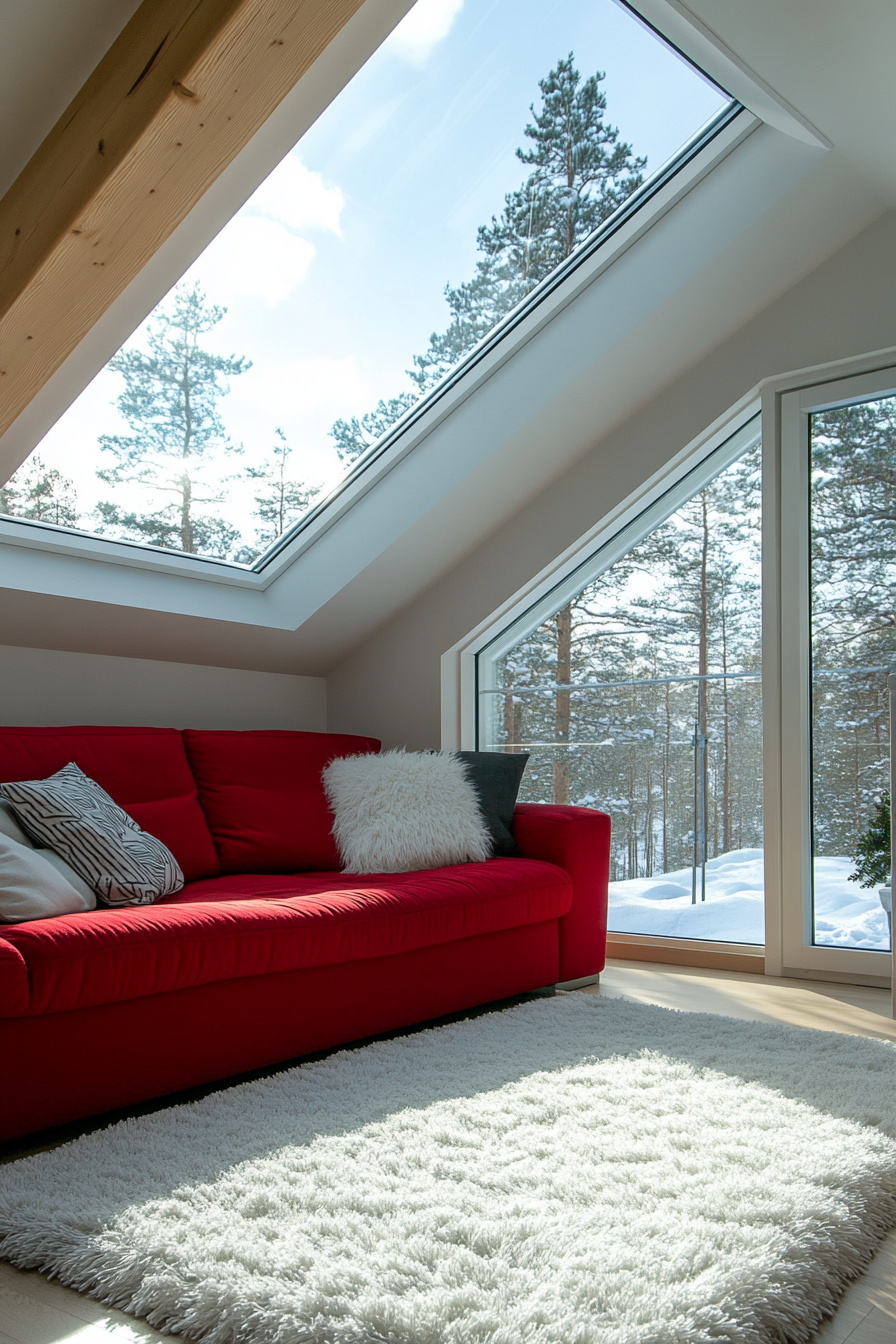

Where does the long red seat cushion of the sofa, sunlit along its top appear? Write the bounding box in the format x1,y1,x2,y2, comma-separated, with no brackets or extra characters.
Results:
0,859,572,1016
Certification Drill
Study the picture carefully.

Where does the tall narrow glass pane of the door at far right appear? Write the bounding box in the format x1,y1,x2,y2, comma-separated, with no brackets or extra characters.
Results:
810,396,896,952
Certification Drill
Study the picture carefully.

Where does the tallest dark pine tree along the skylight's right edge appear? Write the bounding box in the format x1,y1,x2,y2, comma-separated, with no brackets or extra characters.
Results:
330,52,646,462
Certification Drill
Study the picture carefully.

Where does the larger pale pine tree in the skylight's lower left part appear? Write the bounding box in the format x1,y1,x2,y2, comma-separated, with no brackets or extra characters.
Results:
97,285,251,558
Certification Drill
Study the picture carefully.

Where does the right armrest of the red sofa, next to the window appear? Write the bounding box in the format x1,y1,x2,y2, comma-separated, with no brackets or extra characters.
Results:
513,802,610,981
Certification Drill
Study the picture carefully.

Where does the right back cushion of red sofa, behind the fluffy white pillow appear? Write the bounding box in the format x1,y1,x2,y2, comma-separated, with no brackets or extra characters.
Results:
184,728,380,872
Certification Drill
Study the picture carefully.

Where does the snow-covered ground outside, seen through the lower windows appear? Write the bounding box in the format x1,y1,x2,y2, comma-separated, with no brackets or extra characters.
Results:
609,849,889,952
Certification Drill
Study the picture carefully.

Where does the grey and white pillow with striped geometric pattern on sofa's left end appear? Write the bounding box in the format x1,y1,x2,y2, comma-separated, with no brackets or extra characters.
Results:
0,761,184,906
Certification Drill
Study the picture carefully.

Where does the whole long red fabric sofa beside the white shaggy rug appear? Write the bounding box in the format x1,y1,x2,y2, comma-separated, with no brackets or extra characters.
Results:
0,727,610,1138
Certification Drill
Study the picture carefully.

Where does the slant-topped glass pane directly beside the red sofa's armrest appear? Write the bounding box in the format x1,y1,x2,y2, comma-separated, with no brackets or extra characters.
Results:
480,433,764,943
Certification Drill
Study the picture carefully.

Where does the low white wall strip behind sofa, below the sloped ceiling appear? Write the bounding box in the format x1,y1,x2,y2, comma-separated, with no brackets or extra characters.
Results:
0,644,326,732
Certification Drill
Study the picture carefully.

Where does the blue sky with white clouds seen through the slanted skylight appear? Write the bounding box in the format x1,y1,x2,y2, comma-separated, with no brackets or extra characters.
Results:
24,0,724,551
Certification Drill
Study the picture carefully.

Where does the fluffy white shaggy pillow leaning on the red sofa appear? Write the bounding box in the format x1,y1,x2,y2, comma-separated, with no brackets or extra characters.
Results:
324,751,492,872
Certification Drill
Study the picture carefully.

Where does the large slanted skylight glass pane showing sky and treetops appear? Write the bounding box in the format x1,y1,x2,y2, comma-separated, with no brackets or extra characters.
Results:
0,0,728,564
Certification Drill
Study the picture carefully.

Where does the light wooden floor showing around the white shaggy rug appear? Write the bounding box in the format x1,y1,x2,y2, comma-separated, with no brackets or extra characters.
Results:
0,961,896,1344
